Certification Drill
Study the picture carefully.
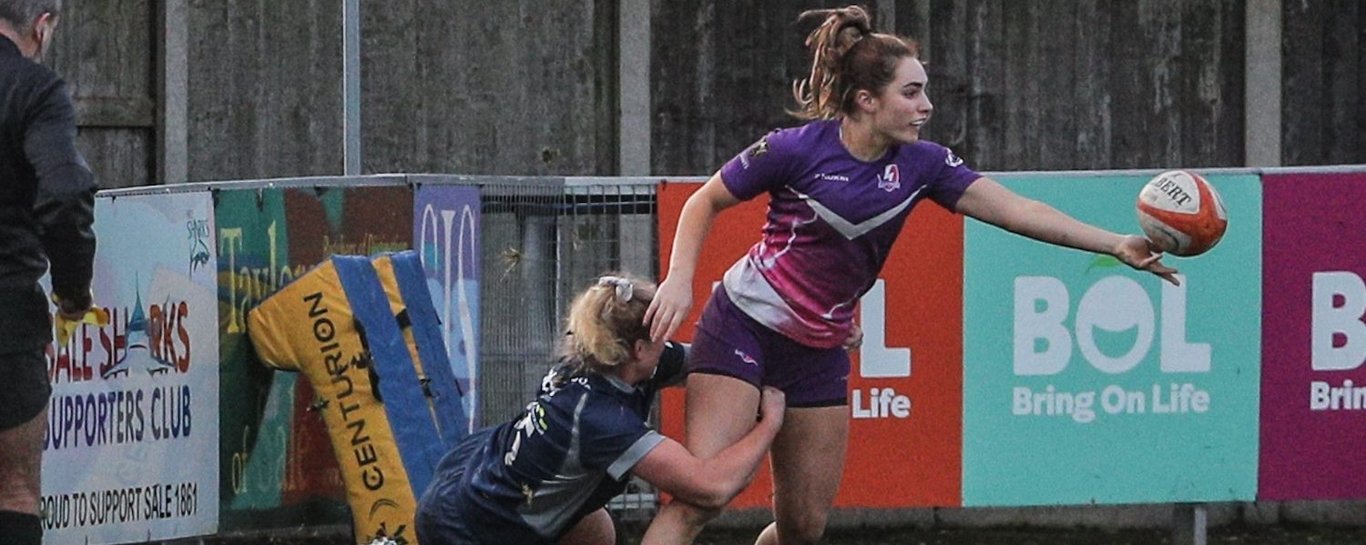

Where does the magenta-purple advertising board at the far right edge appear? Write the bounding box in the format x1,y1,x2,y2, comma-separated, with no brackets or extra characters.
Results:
1258,172,1366,500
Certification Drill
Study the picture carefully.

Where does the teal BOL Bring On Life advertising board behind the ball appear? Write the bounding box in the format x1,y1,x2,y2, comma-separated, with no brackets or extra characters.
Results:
963,175,1261,505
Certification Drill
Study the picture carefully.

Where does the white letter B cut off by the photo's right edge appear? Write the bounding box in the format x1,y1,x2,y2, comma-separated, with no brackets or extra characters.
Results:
1310,270,1366,372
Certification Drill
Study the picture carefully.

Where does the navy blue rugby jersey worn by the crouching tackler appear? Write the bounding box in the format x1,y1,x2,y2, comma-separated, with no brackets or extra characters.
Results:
418,341,686,545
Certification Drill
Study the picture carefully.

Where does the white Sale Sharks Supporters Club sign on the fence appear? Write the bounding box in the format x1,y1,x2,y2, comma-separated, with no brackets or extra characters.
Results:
42,193,219,544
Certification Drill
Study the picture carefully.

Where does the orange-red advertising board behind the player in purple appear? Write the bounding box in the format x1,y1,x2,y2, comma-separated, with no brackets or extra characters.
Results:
658,182,963,508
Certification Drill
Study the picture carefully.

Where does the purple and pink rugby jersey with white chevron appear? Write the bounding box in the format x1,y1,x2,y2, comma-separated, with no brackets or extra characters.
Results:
721,120,981,348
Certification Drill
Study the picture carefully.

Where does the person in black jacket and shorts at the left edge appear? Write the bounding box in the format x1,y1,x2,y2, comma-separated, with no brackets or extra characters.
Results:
0,0,96,545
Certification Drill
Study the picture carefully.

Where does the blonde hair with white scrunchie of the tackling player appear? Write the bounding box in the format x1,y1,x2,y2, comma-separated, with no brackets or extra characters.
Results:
560,273,656,372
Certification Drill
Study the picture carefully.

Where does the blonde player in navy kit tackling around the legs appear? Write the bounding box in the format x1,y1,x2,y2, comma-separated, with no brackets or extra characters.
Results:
417,276,784,545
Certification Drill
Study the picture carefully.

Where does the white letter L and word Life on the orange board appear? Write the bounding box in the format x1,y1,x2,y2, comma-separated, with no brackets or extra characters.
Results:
850,279,911,418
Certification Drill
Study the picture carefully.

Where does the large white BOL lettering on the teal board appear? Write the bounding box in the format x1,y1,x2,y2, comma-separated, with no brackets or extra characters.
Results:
1014,276,1210,376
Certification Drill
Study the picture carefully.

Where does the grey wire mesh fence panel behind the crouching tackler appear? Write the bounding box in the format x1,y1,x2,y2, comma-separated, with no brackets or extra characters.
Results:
452,176,657,519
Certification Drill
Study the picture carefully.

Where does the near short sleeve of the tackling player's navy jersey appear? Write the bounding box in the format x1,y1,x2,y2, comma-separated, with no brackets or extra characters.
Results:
579,403,664,481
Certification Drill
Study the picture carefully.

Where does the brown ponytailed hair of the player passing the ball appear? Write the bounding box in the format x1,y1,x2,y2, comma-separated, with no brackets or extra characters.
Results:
790,5,918,119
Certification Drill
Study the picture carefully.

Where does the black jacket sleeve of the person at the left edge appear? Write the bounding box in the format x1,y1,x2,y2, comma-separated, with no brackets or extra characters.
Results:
23,79,97,306
